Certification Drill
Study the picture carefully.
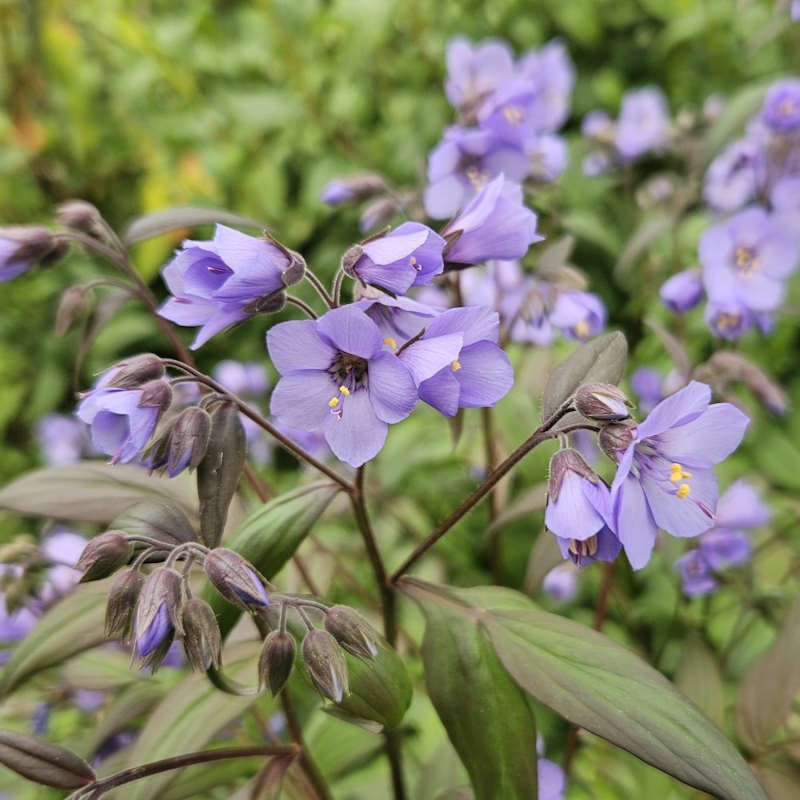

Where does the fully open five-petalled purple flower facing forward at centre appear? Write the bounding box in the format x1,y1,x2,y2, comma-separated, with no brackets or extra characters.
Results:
267,306,424,467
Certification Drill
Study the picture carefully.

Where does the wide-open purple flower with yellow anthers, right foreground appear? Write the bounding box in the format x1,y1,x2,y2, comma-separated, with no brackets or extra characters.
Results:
611,381,749,569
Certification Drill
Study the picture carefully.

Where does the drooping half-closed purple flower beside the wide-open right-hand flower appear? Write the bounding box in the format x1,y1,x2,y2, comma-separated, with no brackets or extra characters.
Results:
544,449,620,567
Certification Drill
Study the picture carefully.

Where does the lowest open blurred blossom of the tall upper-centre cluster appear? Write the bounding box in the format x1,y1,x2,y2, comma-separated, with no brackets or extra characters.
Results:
424,125,531,219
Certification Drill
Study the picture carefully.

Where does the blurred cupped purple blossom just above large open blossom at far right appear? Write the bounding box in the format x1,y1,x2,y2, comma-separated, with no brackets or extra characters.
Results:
703,139,766,211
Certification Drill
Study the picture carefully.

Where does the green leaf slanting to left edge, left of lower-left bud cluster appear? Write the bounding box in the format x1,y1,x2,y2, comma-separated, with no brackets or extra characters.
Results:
0,580,109,695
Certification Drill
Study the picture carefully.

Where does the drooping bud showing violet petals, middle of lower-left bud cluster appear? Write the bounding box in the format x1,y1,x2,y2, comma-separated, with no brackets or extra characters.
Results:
134,567,183,669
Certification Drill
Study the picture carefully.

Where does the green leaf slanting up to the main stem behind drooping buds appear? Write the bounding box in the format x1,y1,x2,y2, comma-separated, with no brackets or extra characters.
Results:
203,481,339,638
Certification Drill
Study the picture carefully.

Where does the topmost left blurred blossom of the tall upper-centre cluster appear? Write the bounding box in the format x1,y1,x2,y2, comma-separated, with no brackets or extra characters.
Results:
444,37,514,110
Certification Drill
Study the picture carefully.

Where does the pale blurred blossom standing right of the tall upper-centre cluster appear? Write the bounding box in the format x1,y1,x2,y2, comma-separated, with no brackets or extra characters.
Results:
614,86,670,161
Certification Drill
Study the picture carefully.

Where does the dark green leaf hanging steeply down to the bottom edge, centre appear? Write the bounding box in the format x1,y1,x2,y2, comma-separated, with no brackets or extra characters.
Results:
404,581,537,800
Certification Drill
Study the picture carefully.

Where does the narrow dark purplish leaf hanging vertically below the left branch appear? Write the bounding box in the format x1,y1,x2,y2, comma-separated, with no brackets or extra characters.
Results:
197,402,246,547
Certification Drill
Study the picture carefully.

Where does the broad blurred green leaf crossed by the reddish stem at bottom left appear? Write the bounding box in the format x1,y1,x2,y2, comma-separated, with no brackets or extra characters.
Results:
119,642,269,800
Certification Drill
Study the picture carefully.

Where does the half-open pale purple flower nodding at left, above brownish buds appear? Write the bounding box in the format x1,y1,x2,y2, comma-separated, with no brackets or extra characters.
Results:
75,372,172,464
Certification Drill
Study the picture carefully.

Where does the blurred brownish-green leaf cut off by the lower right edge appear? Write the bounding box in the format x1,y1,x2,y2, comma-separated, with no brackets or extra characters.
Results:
736,595,800,750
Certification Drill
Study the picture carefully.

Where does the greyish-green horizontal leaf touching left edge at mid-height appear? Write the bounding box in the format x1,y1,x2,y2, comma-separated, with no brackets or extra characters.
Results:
0,461,197,525
